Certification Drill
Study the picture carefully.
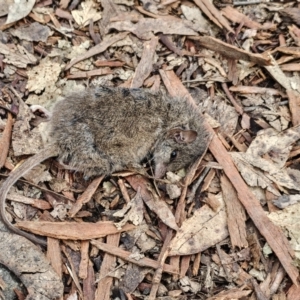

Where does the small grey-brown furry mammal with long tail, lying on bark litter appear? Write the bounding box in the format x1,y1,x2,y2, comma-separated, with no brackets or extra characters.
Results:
0,87,209,244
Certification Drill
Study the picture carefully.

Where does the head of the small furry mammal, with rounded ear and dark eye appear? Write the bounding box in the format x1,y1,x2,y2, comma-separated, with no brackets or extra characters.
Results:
153,126,207,178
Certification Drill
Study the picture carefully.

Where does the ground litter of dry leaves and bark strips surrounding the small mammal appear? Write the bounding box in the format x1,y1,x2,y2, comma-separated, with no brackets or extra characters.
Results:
0,0,300,300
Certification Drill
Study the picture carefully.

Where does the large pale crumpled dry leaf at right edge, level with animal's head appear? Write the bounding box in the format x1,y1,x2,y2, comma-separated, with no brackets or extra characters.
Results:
231,126,300,196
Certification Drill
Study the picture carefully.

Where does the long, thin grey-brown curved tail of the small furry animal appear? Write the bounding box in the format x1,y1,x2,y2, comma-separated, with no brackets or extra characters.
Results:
0,145,58,246
